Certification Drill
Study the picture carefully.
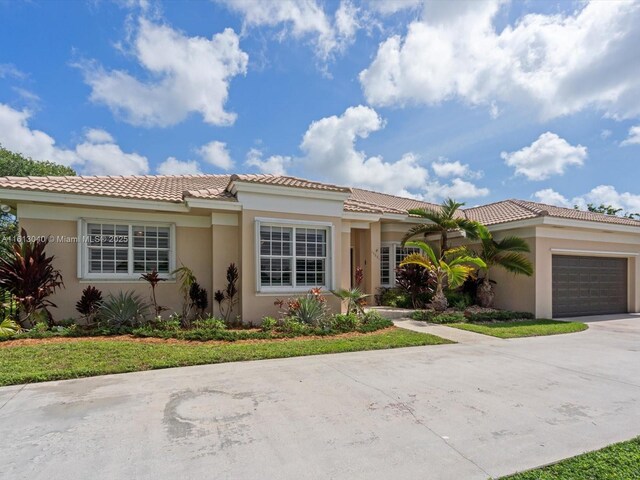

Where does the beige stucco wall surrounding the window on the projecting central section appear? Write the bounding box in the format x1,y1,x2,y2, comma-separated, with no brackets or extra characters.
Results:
240,210,350,324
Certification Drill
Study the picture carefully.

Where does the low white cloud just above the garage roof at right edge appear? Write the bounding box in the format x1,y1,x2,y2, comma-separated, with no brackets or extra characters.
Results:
534,185,640,213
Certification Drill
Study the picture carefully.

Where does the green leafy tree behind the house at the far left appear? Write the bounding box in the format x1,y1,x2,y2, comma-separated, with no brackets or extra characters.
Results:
0,145,76,256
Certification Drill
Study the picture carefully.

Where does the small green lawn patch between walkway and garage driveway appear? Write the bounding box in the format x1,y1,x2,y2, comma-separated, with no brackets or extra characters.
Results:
448,319,588,338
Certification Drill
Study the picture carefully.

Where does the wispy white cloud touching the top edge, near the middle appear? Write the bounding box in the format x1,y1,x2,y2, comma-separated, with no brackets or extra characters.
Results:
218,0,359,60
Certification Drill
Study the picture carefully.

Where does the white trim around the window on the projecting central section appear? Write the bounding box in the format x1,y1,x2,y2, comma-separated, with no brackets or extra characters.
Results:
254,217,336,294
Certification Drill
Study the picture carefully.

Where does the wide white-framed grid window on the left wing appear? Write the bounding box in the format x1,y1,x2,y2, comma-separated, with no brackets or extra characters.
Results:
78,220,175,280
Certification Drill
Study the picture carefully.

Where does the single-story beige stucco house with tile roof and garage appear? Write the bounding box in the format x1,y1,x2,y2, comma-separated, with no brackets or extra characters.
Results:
0,175,640,322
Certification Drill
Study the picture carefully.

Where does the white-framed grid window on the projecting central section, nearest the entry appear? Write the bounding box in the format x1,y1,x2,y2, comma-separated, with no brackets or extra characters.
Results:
256,220,332,292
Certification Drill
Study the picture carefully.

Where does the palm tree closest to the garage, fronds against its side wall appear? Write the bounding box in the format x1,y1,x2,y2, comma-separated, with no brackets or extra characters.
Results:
476,225,533,307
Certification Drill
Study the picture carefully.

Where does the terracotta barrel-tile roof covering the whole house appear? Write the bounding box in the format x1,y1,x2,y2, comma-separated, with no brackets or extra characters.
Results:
0,174,640,227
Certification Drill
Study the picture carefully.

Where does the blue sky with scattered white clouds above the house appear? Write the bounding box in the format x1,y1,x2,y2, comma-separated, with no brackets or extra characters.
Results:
0,0,640,212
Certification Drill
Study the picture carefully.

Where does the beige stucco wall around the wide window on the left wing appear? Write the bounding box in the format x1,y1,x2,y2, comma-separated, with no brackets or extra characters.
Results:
18,218,212,320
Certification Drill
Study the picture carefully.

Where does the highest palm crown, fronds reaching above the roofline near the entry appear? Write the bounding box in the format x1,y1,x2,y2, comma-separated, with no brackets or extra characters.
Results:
402,198,480,253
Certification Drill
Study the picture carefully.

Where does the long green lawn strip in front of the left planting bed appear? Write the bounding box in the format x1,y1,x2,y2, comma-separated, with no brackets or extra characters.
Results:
0,328,452,385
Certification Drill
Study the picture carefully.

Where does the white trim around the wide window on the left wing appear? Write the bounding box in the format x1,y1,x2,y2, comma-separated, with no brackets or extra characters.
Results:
78,218,176,282
